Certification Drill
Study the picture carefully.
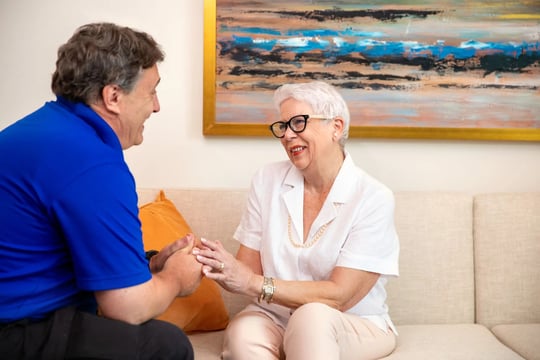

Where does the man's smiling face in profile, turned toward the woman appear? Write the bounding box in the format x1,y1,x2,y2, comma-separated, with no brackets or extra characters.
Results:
117,65,160,150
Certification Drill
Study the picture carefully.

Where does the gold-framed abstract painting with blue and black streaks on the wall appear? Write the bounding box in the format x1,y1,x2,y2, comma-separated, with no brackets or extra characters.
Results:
203,0,540,141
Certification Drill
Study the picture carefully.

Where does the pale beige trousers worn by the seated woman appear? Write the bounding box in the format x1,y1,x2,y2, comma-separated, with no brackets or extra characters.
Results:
222,303,396,360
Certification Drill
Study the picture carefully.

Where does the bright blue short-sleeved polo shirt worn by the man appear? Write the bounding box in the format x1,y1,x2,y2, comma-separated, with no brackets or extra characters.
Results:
0,97,151,323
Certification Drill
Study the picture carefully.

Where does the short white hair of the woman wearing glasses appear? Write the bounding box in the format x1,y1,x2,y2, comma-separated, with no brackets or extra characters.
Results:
274,81,351,146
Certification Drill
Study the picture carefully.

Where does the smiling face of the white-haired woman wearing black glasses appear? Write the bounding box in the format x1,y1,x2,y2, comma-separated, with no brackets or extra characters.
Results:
280,98,336,170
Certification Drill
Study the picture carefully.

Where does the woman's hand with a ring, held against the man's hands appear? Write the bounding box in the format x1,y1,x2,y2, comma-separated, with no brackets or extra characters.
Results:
193,239,262,296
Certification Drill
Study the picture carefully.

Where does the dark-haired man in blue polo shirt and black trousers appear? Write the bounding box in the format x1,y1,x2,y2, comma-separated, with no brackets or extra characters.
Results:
0,23,201,360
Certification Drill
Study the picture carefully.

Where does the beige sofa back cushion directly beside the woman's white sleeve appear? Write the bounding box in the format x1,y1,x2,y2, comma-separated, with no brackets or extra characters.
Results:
387,192,474,325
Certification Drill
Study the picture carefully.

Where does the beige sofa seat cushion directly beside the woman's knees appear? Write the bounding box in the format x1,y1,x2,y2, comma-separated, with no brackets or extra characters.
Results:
384,324,523,360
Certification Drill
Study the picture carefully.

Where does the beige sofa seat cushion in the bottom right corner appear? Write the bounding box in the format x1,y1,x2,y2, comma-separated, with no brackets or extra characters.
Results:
491,324,540,360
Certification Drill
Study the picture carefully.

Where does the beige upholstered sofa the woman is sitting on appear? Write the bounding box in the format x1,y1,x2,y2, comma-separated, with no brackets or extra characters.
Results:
138,188,540,360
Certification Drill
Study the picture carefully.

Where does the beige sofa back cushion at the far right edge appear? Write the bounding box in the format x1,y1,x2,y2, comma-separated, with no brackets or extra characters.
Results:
474,193,540,327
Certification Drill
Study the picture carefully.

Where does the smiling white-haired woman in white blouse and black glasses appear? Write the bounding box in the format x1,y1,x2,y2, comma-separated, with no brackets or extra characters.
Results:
195,82,399,360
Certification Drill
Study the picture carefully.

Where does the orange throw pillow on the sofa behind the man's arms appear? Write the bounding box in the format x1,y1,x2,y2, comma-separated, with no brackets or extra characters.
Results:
139,190,229,332
